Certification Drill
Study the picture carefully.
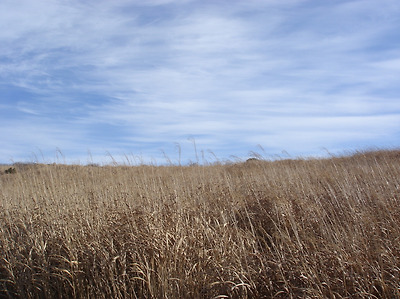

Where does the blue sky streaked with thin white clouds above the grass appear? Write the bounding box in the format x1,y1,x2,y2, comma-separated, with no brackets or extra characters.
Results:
0,0,400,164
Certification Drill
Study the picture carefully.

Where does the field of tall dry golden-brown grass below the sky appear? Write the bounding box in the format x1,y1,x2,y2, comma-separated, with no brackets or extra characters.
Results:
0,150,400,298
